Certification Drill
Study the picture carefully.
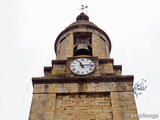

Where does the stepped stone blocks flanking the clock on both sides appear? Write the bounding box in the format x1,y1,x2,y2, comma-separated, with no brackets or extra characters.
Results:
44,57,122,77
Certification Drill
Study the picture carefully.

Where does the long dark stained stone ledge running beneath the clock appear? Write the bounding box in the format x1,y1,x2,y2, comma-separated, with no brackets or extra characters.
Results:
32,75,134,85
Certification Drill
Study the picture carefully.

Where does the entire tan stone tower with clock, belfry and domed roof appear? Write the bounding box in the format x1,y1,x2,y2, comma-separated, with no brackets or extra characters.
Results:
29,13,138,120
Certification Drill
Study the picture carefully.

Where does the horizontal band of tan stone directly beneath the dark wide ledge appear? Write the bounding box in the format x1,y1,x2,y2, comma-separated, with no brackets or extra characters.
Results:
33,82,133,94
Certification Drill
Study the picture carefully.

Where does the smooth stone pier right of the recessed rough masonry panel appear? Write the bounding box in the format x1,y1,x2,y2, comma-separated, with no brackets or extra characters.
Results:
111,91,138,120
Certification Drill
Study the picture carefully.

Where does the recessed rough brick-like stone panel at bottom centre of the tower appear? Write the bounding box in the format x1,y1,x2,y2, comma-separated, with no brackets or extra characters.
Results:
55,94,112,120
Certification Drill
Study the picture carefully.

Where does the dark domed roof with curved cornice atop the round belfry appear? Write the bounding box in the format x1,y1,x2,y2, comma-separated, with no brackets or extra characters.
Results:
54,12,111,52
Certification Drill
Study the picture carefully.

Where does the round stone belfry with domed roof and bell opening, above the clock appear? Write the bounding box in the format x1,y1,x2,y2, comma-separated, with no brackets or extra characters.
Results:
55,12,111,60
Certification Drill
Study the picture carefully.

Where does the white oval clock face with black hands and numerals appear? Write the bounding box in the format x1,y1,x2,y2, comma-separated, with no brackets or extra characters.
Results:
70,58,95,75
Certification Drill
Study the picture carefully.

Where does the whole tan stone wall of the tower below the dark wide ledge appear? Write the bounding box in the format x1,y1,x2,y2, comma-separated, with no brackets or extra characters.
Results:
30,79,138,120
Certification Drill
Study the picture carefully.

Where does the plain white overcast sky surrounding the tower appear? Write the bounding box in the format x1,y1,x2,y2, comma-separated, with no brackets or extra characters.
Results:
0,0,160,120
